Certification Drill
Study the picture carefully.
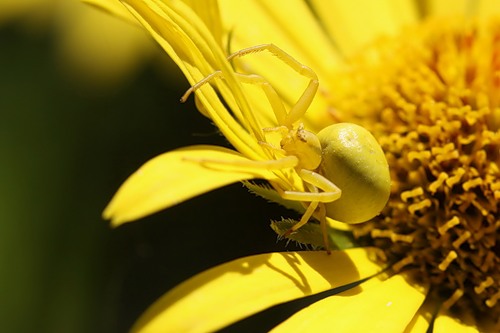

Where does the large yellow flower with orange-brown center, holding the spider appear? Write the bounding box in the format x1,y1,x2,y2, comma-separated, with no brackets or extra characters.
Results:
88,0,500,332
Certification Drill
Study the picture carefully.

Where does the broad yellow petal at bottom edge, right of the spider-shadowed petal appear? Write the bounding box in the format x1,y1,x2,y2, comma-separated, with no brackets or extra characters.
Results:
275,275,427,333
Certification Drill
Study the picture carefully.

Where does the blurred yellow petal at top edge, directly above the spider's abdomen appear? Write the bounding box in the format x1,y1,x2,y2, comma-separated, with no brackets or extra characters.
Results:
311,0,418,56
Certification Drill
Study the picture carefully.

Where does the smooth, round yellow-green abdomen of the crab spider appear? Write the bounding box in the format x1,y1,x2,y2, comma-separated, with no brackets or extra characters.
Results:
318,123,391,223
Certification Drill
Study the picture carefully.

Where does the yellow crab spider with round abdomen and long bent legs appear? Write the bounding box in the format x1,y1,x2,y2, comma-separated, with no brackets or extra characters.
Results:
181,44,390,251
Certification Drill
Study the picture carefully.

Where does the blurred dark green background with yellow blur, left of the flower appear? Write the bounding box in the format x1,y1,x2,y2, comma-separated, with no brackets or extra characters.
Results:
0,0,302,332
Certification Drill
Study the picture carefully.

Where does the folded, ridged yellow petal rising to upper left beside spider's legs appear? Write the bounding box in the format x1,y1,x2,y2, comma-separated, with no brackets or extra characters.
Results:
123,0,264,159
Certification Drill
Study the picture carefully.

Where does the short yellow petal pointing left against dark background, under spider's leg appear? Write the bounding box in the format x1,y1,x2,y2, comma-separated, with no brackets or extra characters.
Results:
103,146,275,226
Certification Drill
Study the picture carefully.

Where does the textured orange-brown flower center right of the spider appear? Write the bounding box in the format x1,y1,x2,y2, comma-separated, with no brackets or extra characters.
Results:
332,21,500,318
